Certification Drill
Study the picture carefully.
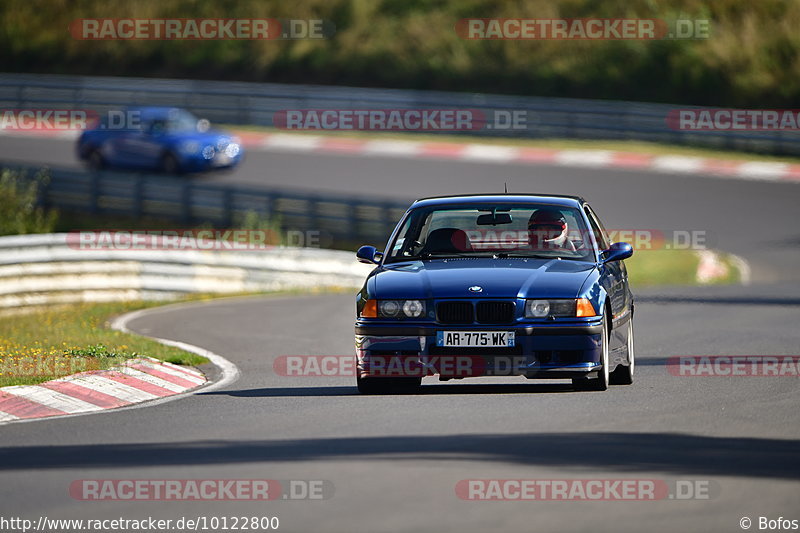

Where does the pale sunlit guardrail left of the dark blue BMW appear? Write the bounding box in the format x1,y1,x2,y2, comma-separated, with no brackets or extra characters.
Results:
0,233,371,309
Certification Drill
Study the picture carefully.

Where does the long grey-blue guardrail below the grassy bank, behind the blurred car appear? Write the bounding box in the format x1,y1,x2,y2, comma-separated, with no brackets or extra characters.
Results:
0,73,800,154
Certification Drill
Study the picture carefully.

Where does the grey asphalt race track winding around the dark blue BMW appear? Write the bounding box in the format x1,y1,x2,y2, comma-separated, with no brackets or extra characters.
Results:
0,134,800,532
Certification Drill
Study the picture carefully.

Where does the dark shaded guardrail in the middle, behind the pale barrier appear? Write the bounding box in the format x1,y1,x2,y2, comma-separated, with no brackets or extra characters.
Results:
0,161,411,247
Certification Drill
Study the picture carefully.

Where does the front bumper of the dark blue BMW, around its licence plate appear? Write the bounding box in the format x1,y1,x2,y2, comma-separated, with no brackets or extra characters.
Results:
355,319,603,379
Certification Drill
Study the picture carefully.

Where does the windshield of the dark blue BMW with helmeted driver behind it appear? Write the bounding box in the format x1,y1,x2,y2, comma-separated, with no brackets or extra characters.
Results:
386,203,595,263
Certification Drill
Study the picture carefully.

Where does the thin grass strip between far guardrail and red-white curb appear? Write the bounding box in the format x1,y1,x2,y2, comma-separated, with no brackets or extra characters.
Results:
227,124,800,164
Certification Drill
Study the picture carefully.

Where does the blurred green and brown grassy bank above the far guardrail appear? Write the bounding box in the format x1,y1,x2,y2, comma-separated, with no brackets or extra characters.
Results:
0,0,800,108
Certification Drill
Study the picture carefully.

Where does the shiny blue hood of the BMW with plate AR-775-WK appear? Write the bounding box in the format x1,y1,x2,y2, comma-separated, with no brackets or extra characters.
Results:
372,258,595,299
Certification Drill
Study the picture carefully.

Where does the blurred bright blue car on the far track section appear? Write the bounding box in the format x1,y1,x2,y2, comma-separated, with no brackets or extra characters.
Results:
77,107,244,174
